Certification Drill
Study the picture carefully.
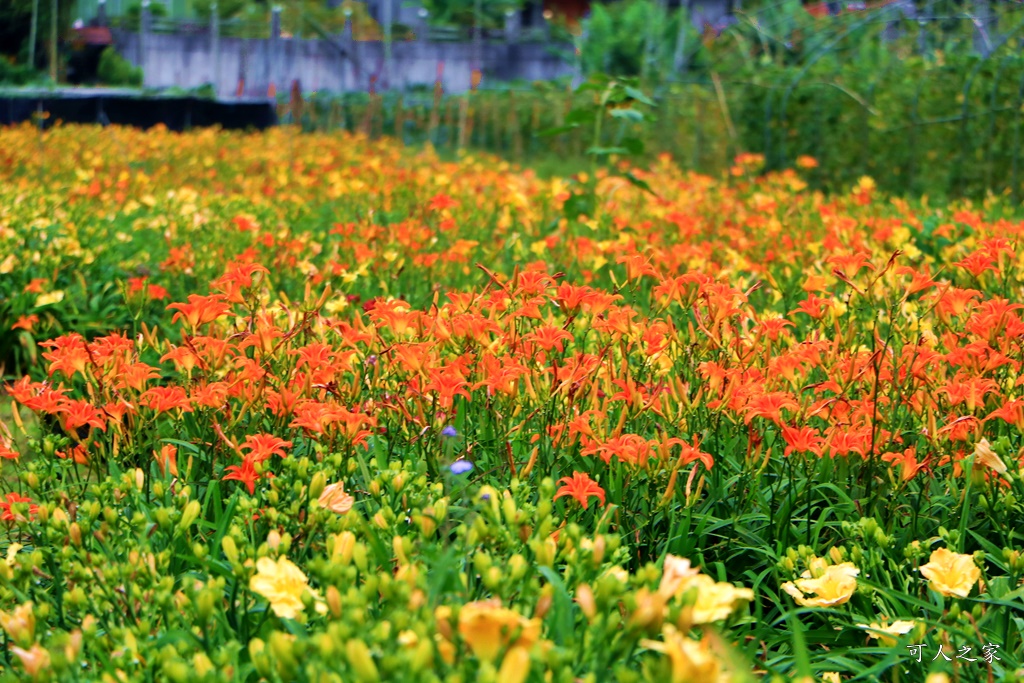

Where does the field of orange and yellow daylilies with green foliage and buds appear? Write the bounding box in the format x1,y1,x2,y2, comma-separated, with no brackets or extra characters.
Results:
0,126,1024,683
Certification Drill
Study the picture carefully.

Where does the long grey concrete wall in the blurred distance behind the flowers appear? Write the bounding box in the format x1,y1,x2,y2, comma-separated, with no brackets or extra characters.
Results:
115,33,572,96
